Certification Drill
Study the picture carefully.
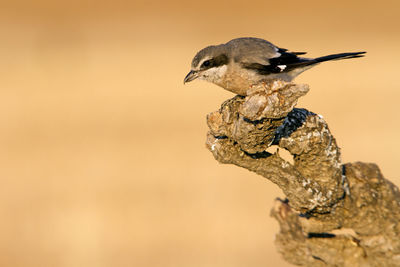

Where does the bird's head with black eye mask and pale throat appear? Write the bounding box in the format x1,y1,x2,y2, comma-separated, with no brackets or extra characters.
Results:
183,45,229,83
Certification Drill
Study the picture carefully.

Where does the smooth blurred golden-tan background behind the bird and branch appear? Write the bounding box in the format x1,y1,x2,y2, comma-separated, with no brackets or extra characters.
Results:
0,0,400,267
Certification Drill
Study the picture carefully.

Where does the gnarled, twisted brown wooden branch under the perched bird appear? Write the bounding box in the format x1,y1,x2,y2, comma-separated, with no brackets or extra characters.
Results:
206,81,400,266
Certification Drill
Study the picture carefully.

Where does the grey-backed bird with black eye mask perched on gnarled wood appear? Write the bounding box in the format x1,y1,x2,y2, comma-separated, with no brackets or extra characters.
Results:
184,37,366,95
